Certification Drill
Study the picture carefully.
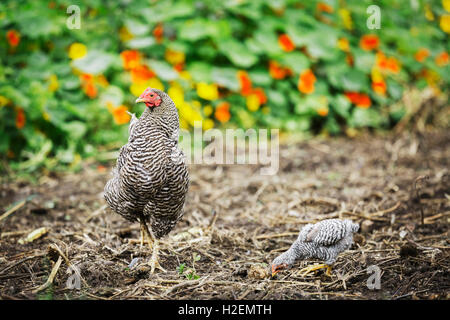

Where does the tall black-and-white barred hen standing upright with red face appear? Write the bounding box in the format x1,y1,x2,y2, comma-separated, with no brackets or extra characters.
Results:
104,88,189,273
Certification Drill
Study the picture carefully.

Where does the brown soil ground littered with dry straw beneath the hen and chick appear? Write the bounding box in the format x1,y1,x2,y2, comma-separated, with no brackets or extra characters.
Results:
0,131,450,299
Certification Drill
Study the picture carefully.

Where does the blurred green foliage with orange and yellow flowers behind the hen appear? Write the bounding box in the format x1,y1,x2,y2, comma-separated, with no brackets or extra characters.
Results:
0,0,450,171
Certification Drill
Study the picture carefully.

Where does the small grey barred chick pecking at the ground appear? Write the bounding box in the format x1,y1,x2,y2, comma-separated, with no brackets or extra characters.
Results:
272,219,359,276
